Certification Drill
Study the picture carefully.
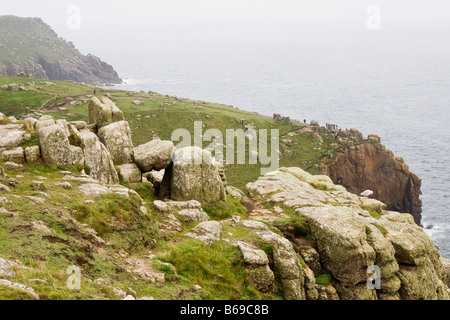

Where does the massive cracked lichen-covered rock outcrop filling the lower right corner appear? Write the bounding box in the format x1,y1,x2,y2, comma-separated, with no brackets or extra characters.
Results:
246,168,450,300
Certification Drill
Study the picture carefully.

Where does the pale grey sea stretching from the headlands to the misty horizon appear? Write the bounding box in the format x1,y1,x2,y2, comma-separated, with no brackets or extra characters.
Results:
89,24,450,258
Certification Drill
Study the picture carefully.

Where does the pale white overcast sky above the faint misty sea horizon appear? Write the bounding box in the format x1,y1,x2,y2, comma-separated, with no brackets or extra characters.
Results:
0,0,450,29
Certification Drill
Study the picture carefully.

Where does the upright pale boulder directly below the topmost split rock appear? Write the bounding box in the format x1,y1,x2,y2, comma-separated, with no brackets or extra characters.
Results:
98,121,133,165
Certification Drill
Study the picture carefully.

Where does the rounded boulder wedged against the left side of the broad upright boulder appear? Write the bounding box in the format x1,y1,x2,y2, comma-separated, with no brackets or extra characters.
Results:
133,139,174,172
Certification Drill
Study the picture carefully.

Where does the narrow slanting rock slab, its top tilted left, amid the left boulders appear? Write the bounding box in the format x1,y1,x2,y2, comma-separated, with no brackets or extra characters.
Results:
78,129,119,184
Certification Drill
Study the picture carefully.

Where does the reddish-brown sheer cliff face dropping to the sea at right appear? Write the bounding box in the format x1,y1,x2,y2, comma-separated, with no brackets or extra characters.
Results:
327,143,422,224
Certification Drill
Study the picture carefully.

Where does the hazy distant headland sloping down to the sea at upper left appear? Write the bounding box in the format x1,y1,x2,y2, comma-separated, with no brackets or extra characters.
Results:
0,16,122,85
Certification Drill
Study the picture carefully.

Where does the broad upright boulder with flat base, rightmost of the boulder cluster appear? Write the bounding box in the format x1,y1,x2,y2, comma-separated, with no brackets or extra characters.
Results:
170,147,225,204
